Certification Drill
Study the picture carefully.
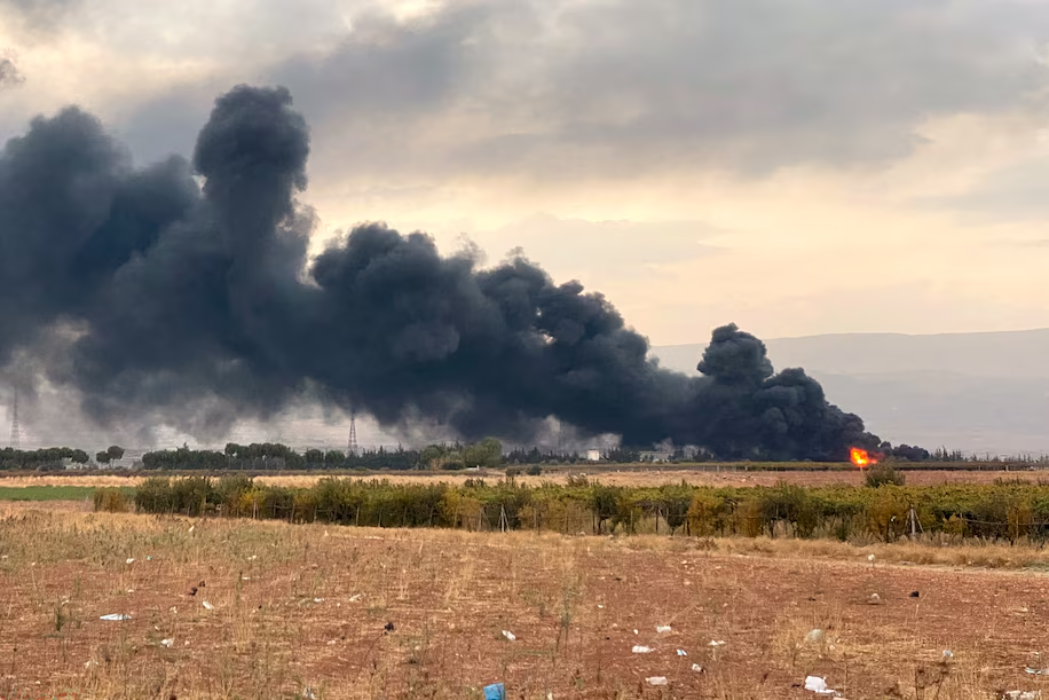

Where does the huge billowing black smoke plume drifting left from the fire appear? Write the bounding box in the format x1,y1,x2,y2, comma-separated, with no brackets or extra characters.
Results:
0,86,878,460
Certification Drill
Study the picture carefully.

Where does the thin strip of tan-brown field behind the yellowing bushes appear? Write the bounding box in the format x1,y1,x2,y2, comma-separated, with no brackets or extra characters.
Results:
0,469,1049,487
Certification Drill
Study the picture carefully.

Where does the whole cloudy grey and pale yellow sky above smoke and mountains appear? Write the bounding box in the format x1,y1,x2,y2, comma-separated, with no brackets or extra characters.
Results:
0,0,1049,344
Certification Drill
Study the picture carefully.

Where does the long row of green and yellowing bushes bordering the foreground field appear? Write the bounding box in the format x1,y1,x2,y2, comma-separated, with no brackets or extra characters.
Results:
122,475,1049,542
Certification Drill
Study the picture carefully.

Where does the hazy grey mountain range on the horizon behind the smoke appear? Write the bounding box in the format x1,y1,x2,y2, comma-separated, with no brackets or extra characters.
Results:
651,328,1049,454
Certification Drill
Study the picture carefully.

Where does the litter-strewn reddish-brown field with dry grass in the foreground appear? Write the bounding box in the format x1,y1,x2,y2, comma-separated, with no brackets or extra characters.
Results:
0,504,1049,700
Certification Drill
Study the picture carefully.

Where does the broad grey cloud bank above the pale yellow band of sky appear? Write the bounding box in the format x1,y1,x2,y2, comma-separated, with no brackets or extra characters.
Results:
83,0,1049,182
